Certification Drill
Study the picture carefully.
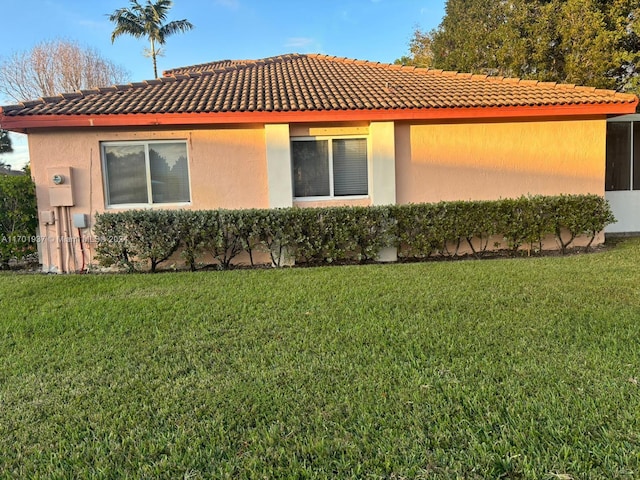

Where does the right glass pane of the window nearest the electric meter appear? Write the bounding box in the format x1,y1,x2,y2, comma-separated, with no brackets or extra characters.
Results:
149,142,190,203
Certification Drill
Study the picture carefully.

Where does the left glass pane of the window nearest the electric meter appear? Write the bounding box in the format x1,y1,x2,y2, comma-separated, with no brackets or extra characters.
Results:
104,145,148,205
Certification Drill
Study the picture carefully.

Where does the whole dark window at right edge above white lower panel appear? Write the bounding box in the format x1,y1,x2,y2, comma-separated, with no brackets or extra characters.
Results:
605,122,640,191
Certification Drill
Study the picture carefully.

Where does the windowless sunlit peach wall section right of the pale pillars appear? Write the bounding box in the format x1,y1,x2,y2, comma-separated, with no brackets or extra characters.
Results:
396,119,606,204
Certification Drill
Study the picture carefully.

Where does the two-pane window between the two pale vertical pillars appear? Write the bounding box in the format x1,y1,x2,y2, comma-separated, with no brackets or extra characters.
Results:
291,138,369,198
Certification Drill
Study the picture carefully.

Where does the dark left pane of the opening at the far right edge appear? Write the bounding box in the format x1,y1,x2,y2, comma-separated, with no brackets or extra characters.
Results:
605,122,631,191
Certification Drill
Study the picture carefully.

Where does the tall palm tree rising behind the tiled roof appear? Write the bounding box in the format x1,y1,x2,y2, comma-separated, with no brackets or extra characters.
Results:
109,0,193,78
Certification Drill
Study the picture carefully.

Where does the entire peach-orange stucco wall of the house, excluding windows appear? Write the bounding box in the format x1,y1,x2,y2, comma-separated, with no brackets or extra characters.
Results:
29,118,606,271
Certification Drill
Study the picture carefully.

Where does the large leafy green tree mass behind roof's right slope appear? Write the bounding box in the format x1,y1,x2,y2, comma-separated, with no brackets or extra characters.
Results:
396,0,640,91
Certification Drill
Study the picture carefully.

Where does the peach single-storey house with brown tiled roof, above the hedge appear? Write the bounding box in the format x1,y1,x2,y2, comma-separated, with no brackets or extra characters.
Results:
0,54,640,272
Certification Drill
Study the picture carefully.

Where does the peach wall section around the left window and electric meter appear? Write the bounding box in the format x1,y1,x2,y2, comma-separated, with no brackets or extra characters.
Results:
29,128,268,271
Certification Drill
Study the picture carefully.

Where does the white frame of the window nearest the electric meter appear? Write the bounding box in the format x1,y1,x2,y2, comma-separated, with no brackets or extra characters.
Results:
100,138,193,209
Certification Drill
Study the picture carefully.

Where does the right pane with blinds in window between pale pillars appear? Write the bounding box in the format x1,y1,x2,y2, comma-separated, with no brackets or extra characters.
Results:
333,138,368,196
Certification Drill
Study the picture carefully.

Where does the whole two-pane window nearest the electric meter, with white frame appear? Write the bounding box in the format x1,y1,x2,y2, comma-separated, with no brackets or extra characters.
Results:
102,141,191,205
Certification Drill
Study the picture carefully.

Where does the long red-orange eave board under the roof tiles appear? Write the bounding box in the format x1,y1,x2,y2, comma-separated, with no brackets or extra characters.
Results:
0,99,638,133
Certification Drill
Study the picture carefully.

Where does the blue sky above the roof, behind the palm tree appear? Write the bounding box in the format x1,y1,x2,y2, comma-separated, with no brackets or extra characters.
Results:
0,0,445,168
